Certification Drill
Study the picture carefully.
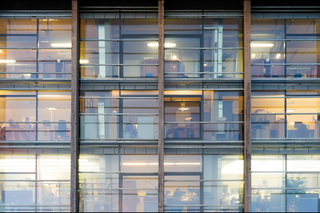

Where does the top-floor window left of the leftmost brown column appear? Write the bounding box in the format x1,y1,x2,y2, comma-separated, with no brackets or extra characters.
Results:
0,18,71,79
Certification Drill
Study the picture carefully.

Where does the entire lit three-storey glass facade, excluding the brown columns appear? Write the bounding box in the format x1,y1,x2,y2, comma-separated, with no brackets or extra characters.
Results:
0,1,320,212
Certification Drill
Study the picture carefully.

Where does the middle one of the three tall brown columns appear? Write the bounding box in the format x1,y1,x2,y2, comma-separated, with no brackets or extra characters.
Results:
158,0,164,212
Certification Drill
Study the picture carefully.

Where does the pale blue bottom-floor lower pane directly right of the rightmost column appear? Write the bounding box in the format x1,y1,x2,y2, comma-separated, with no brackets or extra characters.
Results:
251,189,285,212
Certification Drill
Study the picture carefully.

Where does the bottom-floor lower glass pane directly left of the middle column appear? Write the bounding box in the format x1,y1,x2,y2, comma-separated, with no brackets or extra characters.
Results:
122,175,158,212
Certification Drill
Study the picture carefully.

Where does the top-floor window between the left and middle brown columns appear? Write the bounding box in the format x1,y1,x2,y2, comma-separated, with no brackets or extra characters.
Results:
80,13,158,78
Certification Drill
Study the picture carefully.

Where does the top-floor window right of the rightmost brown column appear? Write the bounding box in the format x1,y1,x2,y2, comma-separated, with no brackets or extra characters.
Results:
251,14,320,78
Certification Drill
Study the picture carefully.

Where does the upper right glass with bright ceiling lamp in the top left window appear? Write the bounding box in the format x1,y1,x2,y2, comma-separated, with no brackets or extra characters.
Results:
39,19,71,48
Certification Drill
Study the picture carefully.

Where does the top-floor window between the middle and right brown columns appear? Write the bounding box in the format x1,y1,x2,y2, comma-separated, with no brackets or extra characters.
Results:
164,12,243,78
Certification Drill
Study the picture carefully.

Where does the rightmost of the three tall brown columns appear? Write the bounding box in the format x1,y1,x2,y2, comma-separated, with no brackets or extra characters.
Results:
243,0,251,212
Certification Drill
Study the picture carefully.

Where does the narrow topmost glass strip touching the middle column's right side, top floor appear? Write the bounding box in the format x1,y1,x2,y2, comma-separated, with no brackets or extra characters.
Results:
164,19,202,35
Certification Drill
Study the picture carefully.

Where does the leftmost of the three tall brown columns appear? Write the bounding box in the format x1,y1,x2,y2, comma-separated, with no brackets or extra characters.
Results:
70,0,79,212
